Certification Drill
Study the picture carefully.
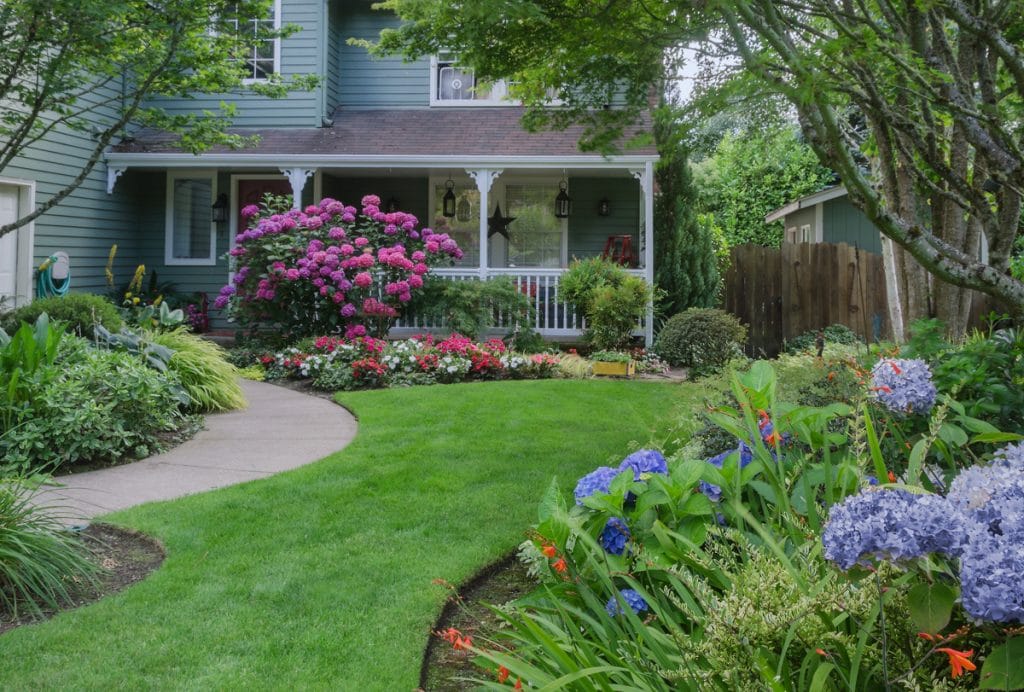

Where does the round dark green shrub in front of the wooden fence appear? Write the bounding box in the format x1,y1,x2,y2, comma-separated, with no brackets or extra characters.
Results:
653,307,746,374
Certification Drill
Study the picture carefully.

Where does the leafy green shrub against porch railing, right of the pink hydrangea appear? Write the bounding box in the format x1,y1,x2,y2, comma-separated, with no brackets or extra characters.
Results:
414,276,534,339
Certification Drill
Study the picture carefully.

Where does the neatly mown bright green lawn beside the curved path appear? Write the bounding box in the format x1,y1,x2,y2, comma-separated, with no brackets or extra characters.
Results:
0,381,700,691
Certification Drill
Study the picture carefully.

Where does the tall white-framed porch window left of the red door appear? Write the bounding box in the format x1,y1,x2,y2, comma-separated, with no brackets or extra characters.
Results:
164,171,217,266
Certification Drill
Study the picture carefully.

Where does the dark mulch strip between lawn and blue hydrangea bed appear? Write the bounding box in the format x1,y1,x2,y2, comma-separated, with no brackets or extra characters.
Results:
420,555,537,692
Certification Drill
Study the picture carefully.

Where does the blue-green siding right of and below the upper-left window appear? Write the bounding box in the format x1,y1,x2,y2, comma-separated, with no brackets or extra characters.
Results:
146,0,327,127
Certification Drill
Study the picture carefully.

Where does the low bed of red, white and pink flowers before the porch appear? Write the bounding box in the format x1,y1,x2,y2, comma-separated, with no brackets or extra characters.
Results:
261,334,559,391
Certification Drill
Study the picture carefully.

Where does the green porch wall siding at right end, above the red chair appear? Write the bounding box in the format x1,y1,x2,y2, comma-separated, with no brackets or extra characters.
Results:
569,178,642,262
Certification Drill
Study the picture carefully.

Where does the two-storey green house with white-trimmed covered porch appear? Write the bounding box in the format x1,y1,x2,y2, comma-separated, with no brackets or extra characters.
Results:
0,0,657,338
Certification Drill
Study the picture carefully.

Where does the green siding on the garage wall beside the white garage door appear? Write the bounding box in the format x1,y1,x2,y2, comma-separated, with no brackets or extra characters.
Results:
0,87,144,293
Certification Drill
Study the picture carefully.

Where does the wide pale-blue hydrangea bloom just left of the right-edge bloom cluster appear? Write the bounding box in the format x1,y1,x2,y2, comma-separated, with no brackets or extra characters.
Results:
821,489,965,569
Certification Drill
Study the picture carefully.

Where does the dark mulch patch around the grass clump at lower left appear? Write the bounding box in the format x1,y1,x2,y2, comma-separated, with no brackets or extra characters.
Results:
0,524,164,635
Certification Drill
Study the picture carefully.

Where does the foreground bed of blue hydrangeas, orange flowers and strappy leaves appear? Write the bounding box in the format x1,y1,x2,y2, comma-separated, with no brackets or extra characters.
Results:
456,356,1024,690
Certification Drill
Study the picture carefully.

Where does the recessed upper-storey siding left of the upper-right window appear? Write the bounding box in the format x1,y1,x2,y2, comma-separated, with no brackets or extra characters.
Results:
332,0,430,109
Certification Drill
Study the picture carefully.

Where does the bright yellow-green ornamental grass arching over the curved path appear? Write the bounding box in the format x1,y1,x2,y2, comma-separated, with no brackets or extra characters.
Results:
148,327,246,412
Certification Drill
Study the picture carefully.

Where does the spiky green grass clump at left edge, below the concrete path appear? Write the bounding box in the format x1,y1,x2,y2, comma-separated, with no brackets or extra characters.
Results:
0,478,97,616
